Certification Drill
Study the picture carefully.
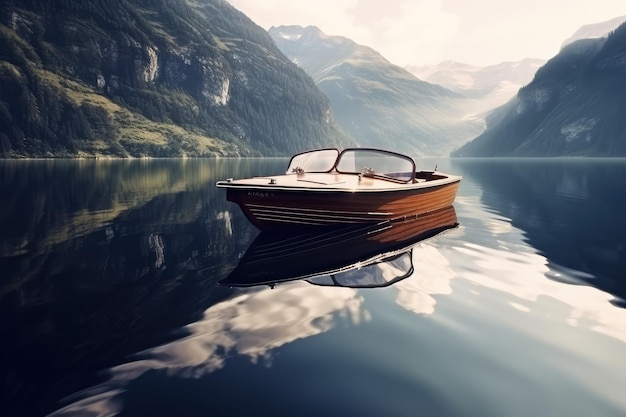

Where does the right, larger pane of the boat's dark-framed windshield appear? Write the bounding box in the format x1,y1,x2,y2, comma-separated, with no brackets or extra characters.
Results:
336,149,415,182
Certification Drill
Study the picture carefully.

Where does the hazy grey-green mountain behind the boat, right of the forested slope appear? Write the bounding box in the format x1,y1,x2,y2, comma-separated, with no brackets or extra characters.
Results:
269,26,483,156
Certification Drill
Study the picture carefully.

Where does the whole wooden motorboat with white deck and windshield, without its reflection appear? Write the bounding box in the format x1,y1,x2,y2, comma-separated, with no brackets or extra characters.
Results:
217,148,461,230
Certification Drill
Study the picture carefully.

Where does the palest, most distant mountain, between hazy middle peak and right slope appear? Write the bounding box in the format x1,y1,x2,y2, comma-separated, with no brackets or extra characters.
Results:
406,58,546,118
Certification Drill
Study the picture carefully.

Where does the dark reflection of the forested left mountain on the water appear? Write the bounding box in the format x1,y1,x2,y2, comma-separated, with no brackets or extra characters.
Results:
0,160,282,415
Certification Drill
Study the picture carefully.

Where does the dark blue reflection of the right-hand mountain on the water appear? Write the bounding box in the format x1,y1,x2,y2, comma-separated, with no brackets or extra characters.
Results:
453,158,626,303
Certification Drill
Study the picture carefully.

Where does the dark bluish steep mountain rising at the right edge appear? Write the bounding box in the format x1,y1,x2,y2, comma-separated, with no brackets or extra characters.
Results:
452,20,626,156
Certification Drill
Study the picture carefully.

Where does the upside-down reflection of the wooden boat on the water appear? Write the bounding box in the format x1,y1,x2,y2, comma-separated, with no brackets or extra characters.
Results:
220,205,458,288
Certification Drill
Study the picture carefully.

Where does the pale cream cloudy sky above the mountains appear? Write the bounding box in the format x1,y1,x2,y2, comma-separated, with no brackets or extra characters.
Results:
227,0,626,67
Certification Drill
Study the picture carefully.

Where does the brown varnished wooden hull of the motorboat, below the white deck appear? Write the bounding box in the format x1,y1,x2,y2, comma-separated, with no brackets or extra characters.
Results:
226,181,460,230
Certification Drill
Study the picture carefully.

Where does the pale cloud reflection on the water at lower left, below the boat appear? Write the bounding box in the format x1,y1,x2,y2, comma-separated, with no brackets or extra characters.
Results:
52,282,370,416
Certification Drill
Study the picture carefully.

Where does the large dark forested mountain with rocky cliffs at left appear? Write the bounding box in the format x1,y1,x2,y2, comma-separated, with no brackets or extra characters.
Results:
0,0,353,157
